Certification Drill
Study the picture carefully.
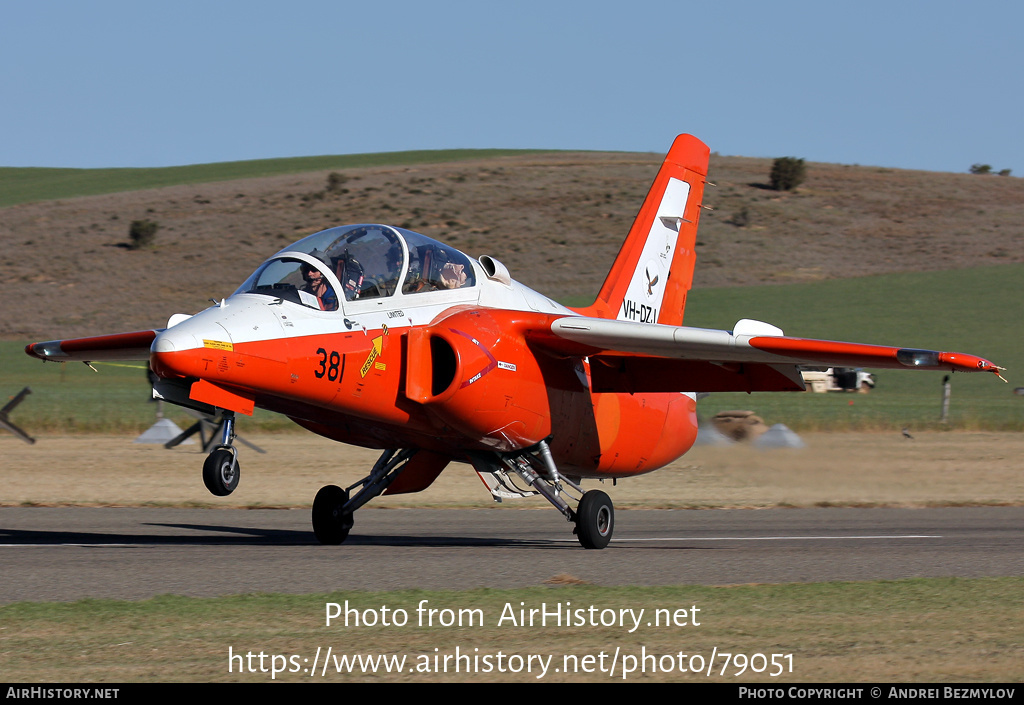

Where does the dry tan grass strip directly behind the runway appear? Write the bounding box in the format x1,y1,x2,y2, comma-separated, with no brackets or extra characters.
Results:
0,432,1024,510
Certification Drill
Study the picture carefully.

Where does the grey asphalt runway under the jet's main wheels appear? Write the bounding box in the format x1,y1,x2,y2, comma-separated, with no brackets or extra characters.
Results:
0,506,1024,603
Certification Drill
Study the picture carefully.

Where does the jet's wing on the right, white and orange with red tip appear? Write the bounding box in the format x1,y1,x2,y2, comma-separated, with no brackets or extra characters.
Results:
534,317,1002,392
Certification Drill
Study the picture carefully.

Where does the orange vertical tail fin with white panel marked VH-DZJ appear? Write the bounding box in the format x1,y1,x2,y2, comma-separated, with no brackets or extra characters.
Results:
579,134,710,326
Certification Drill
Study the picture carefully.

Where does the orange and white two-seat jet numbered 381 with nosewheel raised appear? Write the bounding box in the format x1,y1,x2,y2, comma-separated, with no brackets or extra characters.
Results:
27,135,1001,548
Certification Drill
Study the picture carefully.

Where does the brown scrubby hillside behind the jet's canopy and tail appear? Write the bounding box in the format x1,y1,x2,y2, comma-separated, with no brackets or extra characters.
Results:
0,148,1024,339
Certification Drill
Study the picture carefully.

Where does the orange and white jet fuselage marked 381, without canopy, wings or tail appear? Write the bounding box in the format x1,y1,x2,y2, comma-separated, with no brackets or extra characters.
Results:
151,249,696,476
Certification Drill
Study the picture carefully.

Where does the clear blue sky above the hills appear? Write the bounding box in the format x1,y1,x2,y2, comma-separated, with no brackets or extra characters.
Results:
0,0,1024,175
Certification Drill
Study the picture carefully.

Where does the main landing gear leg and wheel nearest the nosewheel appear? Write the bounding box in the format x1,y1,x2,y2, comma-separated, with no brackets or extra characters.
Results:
312,449,416,545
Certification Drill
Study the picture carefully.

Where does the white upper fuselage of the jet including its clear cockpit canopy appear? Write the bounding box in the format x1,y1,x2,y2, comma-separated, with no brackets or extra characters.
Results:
154,225,573,351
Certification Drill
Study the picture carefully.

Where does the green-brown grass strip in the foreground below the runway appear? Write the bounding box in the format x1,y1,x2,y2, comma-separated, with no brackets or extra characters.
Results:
0,576,1024,686
